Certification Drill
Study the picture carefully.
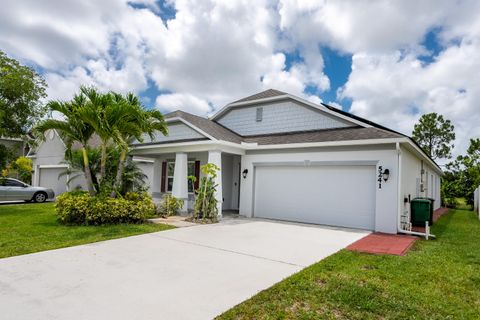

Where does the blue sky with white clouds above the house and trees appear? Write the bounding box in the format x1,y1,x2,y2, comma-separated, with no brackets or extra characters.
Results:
0,0,480,158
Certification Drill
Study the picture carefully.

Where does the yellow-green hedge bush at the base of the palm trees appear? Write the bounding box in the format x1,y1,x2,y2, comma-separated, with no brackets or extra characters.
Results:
55,191,155,225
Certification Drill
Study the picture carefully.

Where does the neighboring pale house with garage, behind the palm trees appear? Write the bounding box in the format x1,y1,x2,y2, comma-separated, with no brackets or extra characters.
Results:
28,130,153,195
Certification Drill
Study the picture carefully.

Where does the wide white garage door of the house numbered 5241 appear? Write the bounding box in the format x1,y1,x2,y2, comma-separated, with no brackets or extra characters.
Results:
254,165,376,230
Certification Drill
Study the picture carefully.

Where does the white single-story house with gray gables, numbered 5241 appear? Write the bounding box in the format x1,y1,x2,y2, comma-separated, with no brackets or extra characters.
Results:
30,89,442,233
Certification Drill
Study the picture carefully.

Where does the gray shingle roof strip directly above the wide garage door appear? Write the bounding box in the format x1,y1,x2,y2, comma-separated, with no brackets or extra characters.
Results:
243,127,403,145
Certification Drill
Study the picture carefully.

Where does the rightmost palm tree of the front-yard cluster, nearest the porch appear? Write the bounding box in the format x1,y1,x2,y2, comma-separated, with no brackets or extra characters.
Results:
112,93,168,197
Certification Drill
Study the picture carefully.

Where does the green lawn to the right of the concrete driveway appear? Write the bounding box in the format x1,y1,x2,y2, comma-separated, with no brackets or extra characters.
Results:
218,210,480,319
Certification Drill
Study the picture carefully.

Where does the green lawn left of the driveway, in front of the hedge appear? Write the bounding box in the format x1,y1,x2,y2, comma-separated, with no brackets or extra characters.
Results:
0,203,173,258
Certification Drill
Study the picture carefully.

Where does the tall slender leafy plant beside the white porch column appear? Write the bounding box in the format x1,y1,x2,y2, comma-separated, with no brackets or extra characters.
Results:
193,163,220,222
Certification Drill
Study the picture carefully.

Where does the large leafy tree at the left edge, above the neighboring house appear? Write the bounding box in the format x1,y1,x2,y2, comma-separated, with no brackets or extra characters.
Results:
0,51,47,137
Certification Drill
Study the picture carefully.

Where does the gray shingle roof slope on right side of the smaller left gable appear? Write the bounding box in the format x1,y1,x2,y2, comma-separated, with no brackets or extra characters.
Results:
165,110,242,143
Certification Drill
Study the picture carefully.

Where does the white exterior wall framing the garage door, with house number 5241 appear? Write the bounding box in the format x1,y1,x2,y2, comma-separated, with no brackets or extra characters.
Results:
240,144,398,233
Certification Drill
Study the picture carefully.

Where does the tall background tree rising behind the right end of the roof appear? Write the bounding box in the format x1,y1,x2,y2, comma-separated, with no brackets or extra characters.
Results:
412,112,455,159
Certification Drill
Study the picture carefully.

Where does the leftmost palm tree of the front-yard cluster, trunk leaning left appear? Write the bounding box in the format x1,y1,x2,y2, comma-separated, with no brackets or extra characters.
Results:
33,94,96,196
